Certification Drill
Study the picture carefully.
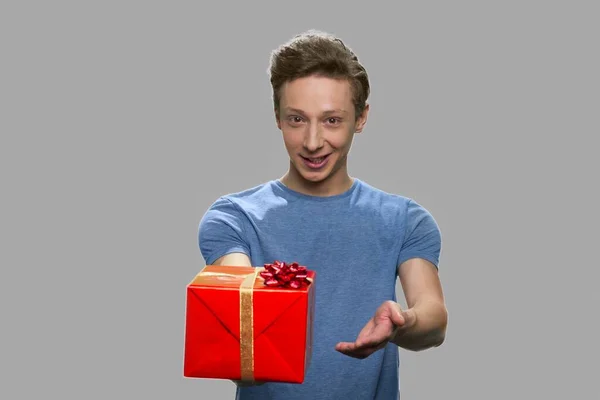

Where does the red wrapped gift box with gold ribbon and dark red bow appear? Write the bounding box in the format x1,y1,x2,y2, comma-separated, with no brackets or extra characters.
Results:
183,262,316,383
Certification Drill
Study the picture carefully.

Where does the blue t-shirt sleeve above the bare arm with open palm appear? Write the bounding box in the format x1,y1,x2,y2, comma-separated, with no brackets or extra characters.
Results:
398,199,442,268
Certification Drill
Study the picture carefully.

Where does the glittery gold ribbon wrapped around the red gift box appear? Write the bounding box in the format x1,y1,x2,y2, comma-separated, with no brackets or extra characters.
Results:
198,267,264,382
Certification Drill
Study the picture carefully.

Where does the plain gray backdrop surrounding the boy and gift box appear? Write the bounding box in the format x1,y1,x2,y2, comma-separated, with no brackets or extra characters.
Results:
0,1,600,400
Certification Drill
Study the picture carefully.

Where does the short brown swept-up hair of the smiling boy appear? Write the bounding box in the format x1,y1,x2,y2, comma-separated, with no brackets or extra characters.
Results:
268,30,370,118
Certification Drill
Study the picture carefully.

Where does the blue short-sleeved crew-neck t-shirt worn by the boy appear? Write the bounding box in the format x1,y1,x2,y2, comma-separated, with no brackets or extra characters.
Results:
198,178,441,400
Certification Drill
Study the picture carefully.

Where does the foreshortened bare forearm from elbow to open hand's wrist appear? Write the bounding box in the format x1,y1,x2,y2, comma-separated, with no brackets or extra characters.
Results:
391,301,448,351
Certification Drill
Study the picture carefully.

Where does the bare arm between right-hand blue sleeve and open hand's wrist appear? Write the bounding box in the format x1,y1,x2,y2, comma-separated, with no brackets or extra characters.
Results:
392,258,448,351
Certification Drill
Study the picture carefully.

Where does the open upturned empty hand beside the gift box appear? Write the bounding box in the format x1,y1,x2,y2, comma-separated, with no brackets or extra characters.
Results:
335,300,416,359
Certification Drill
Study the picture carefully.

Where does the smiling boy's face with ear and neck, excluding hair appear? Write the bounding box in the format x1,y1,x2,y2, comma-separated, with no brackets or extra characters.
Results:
276,76,368,192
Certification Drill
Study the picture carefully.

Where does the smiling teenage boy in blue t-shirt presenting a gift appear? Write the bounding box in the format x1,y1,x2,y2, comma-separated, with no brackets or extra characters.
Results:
198,31,447,400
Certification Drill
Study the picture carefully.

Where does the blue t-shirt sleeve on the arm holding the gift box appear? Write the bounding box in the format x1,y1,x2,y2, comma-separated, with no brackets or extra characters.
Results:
198,197,250,265
